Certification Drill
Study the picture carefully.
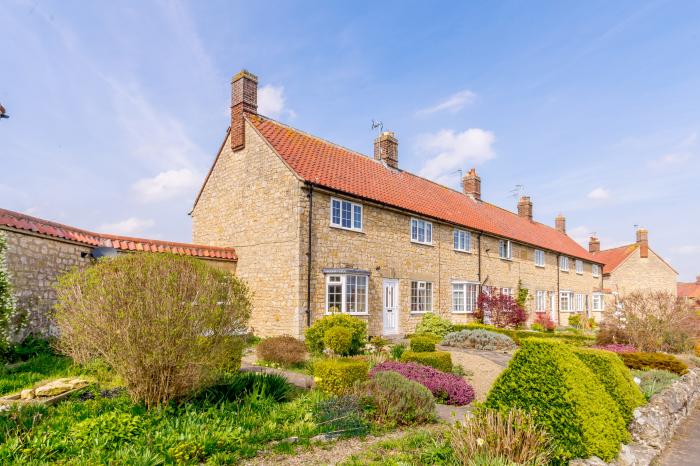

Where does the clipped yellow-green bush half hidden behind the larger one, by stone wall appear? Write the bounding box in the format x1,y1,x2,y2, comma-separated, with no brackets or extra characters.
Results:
573,348,645,424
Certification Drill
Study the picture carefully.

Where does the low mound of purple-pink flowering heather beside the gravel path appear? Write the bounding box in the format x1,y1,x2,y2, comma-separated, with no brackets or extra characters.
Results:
370,361,475,406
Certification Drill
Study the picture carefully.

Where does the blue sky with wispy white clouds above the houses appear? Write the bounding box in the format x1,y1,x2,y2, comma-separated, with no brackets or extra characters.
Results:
0,0,700,280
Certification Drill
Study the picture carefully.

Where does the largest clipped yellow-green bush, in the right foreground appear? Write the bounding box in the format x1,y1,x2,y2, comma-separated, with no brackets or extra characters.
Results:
485,338,629,463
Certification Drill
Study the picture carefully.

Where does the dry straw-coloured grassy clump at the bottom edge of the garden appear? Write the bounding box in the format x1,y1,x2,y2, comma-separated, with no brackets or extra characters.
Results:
450,409,551,466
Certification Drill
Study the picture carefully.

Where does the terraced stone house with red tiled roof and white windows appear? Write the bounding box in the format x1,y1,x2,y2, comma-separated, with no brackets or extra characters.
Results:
191,71,603,336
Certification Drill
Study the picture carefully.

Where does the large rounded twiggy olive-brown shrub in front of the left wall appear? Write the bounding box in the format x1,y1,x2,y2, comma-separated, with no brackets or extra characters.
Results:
54,253,251,407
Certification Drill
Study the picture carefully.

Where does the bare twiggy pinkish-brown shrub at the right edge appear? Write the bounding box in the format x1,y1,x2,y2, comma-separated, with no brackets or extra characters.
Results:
597,292,700,353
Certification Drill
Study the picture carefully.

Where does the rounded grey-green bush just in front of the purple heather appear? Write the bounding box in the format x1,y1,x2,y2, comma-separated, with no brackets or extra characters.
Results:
355,372,435,425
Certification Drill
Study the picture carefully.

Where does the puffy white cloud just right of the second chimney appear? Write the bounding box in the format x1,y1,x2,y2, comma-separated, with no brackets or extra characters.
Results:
418,128,496,184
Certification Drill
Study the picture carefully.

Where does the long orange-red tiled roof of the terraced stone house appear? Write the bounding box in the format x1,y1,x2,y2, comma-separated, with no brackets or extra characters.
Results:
246,115,599,262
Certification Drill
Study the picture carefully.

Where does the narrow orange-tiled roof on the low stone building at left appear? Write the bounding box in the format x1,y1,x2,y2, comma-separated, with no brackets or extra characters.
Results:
0,209,237,261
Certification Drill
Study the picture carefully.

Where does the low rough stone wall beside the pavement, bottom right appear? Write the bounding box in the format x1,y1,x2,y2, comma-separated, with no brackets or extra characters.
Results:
569,369,700,466
